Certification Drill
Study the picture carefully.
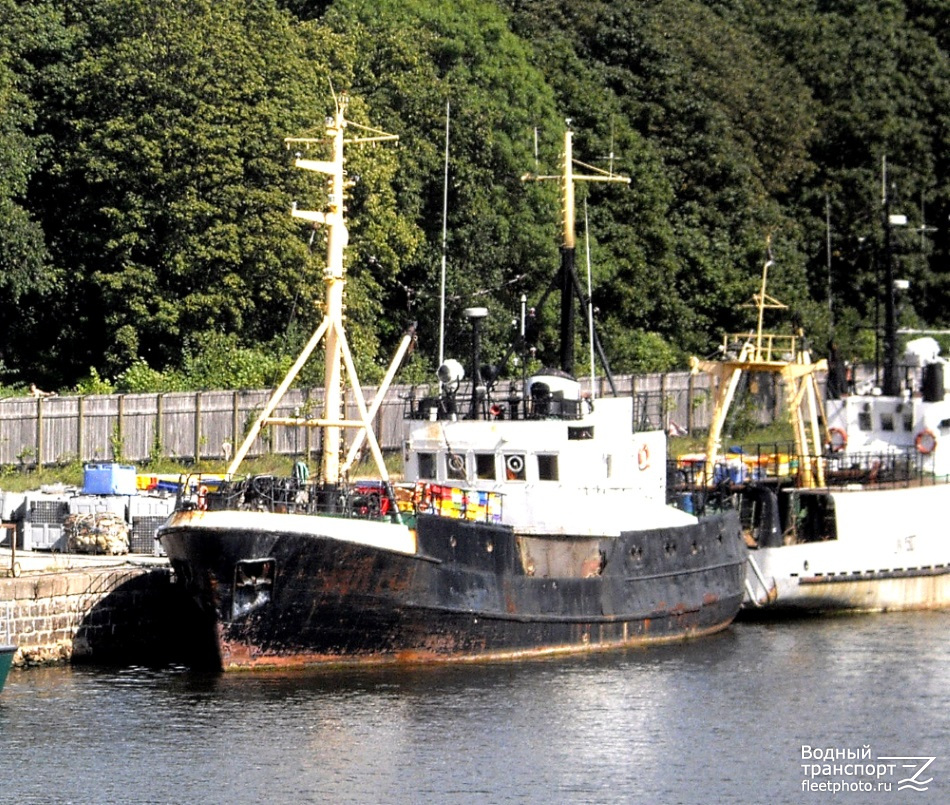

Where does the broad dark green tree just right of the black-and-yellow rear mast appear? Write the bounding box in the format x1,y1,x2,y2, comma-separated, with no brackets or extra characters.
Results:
511,0,816,369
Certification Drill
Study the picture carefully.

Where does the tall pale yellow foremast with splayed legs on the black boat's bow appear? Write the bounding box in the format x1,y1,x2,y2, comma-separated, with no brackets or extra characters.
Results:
227,94,411,484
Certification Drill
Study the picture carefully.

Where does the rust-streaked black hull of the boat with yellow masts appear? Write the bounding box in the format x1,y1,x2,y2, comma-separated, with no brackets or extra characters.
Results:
161,512,746,669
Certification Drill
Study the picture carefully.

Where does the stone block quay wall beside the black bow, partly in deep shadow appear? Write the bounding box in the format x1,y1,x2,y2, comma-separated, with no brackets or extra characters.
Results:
0,566,193,666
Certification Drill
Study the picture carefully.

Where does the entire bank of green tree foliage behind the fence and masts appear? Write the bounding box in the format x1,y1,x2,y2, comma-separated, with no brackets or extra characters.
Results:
0,0,950,390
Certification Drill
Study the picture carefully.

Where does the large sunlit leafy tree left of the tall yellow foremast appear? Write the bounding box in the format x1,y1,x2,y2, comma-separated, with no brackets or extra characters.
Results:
20,0,336,386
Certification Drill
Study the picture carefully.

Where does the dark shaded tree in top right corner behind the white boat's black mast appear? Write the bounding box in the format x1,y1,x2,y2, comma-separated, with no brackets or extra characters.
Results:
719,0,950,349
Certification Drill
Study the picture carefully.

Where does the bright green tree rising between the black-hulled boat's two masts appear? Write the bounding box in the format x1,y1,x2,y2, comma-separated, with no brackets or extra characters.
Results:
323,0,557,370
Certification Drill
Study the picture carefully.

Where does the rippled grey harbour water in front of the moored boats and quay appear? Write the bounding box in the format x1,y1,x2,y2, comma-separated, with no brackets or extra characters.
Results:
0,613,950,803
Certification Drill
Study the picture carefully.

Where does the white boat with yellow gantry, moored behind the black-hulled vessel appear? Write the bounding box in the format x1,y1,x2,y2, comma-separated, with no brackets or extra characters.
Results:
697,242,950,613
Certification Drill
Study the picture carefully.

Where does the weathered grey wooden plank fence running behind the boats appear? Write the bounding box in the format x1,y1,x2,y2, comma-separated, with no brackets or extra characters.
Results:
0,372,781,467
